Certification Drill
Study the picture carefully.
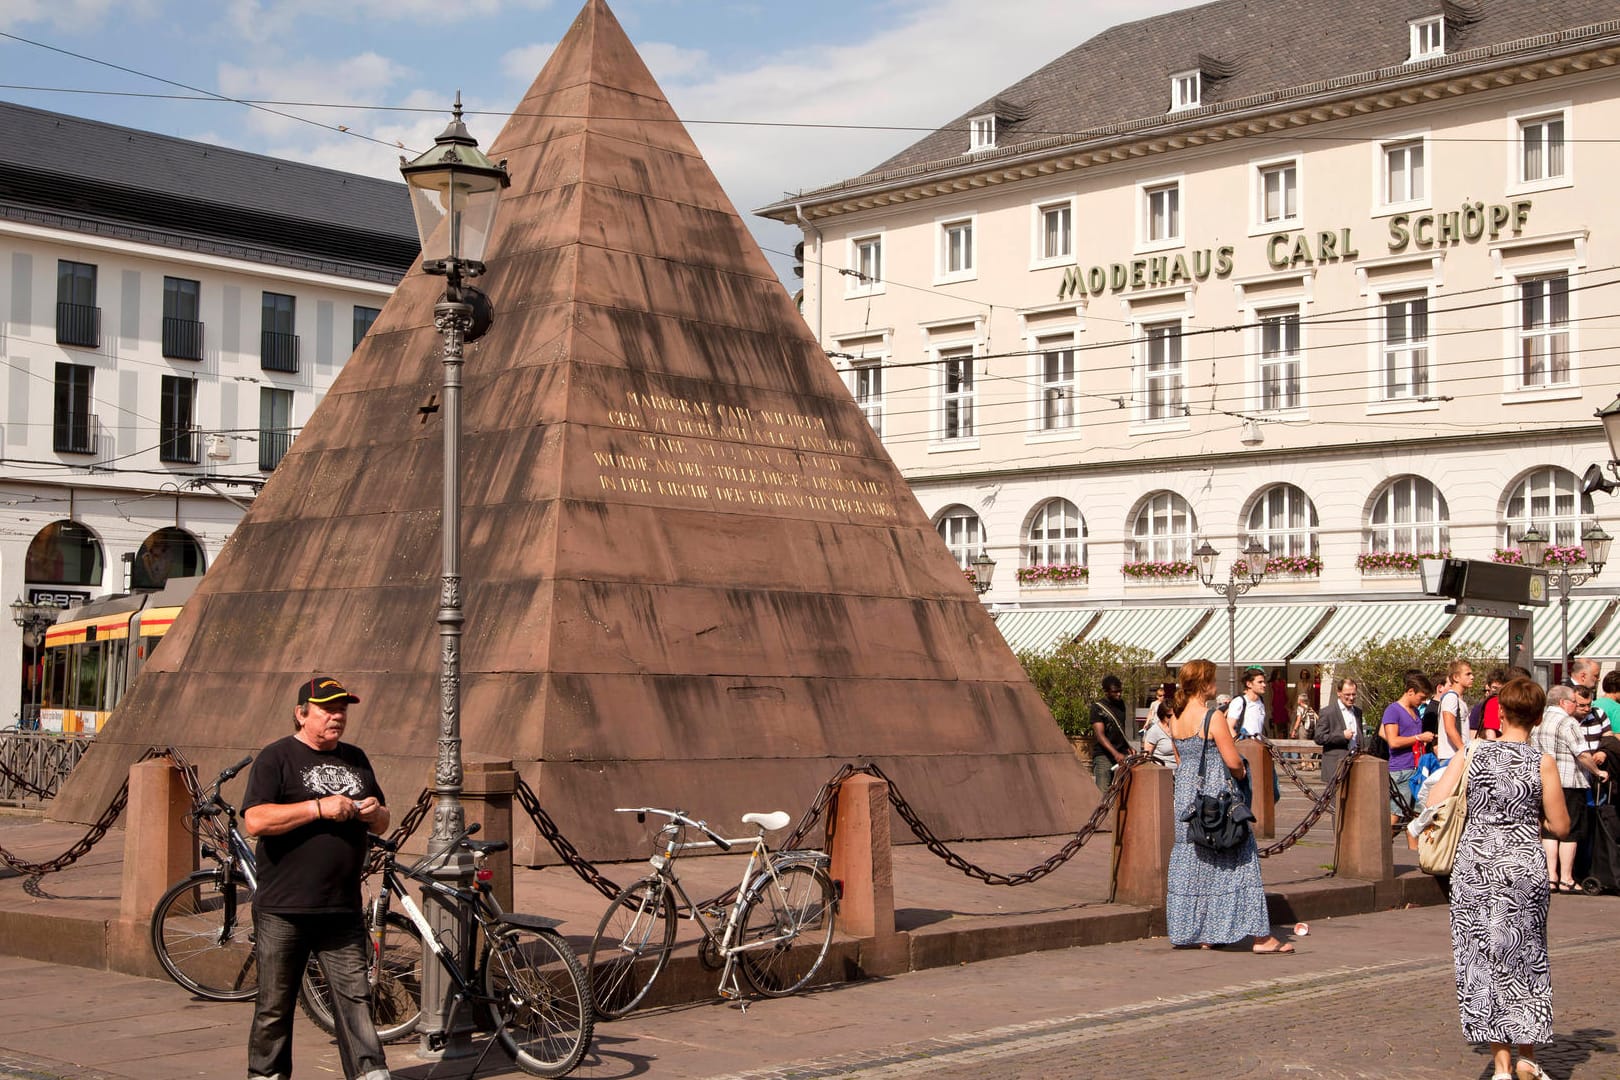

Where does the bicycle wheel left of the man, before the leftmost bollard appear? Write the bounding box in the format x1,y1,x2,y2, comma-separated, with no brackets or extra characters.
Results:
152,870,259,1001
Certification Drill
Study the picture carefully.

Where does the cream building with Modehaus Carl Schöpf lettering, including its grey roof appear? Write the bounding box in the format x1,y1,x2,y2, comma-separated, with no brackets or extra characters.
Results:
760,0,1620,680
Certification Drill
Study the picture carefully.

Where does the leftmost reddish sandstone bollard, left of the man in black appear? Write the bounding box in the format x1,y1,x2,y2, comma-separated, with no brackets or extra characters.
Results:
118,758,198,923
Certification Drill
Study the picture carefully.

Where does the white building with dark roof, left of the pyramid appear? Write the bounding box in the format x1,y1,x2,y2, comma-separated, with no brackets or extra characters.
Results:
0,105,416,722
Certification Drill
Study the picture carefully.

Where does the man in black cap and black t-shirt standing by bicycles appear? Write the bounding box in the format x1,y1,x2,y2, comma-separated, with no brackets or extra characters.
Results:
241,675,389,1080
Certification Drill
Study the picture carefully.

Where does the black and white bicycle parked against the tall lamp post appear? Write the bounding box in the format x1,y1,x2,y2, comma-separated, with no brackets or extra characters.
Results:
369,824,595,1077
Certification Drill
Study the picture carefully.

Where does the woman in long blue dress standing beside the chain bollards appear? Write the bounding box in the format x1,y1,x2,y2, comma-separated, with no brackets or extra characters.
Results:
1165,661,1294,954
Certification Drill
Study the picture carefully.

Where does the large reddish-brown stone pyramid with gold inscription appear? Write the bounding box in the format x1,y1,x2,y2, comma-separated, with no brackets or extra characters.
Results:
53,0,1097,861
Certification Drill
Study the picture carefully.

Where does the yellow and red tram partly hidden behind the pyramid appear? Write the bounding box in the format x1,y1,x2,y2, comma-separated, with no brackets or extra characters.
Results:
39,576,203,733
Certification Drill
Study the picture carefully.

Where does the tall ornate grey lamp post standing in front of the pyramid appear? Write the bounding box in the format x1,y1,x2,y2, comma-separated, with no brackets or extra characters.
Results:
400,94,510,1056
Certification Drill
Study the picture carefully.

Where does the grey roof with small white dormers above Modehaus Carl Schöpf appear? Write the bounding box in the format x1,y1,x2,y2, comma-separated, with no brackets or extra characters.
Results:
861,0,1620,186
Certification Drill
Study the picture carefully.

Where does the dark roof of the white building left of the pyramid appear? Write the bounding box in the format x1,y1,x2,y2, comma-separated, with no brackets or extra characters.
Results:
0,102,420,282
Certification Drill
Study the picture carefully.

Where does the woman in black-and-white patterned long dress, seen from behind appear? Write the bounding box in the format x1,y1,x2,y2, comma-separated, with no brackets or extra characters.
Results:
1429,678,1570,1080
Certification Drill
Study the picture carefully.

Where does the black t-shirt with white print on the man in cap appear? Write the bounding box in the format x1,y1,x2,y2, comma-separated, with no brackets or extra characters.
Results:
241,735,386,915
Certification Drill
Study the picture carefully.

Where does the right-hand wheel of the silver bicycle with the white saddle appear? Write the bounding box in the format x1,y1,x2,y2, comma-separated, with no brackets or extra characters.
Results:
735,863,834,997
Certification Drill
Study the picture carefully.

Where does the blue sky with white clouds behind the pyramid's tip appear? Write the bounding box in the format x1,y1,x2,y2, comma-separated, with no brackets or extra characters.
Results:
0,0,1191,278
